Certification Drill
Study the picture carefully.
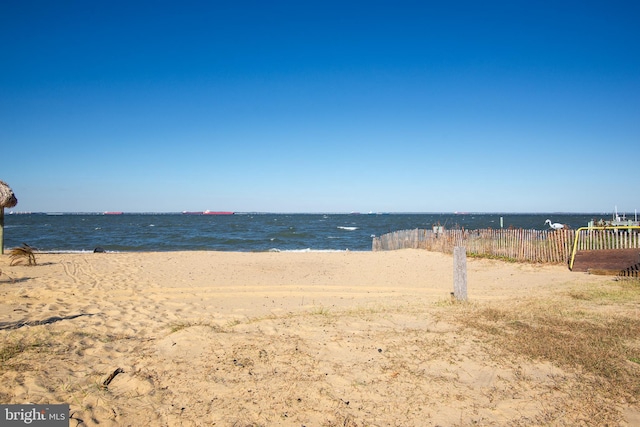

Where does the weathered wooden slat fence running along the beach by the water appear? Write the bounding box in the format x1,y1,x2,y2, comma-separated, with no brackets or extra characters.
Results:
372,227,640,264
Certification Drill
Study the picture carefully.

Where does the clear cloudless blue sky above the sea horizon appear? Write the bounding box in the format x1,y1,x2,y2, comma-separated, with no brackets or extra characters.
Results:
0,0,640,212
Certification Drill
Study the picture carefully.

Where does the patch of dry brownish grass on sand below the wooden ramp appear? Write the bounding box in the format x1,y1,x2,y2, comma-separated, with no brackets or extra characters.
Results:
450,281,640,425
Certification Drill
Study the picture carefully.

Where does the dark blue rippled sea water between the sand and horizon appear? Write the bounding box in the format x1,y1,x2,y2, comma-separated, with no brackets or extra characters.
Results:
4,212,610,252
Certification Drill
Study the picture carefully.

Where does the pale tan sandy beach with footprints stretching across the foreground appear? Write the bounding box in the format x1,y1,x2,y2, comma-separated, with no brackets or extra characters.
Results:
0,250,640,427
